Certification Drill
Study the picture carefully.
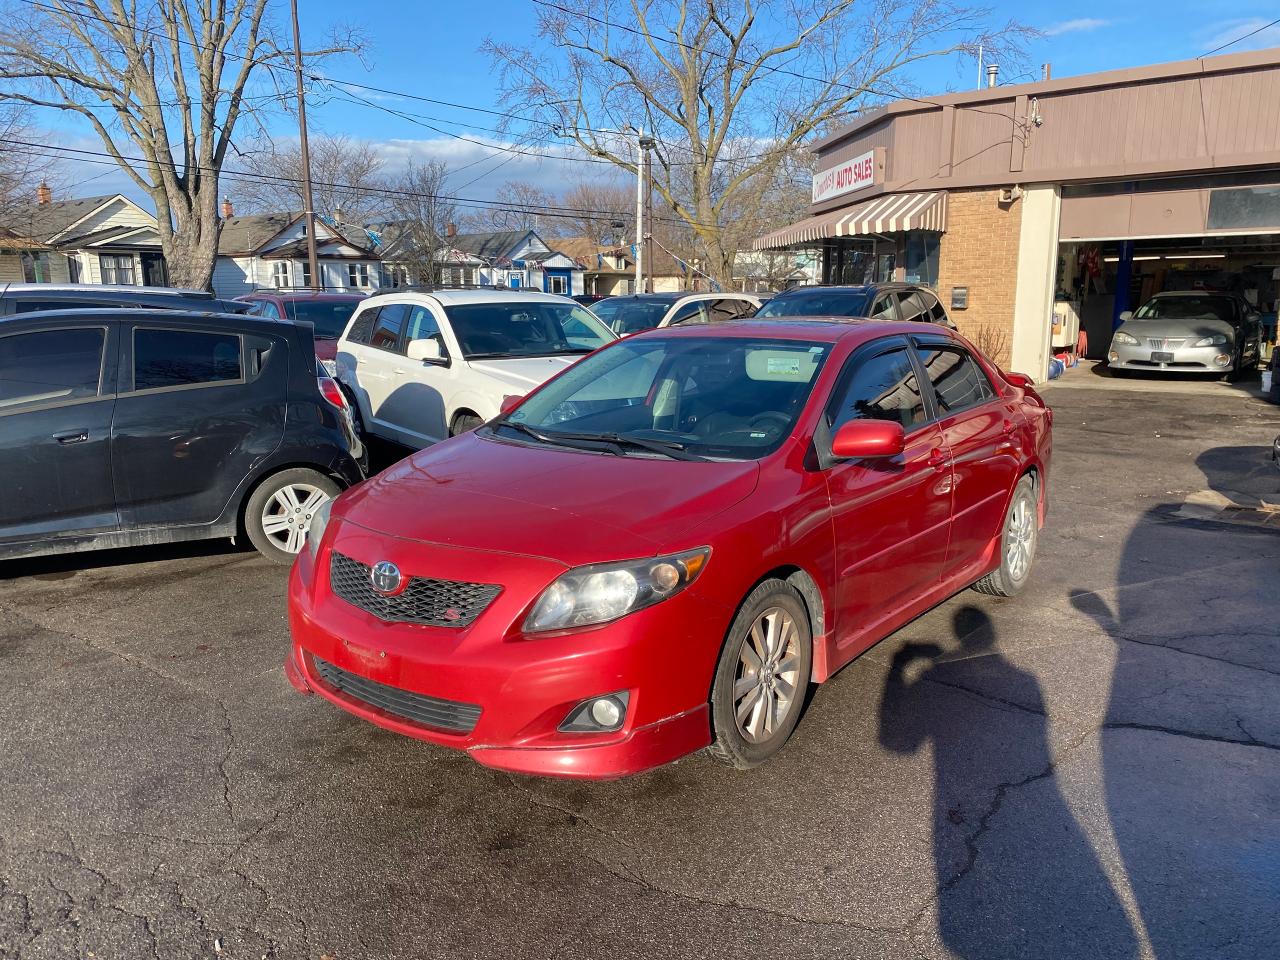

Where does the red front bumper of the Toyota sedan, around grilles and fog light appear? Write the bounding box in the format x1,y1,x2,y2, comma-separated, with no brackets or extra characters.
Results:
285,525,732,780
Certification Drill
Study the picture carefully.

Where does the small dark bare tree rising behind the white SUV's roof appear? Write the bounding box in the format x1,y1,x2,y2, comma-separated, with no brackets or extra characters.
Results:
380,160,458,285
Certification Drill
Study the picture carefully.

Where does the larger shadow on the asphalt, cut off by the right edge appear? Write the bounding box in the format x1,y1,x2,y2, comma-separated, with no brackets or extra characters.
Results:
1070,445,1280,960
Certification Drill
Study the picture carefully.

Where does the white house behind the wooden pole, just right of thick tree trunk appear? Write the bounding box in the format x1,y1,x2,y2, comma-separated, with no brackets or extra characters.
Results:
214,207,383,297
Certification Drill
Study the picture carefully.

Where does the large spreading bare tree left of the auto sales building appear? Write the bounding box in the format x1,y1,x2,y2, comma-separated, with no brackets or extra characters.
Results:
485,0,1029,283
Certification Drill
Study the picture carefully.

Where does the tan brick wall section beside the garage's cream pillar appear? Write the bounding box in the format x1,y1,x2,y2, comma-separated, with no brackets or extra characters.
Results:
938,189,1021,369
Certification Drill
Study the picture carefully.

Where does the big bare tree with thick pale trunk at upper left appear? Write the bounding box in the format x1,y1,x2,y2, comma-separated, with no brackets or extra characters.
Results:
0,0,355,288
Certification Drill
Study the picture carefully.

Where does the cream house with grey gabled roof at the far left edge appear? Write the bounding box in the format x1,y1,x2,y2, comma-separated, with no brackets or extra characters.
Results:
0,183,169,287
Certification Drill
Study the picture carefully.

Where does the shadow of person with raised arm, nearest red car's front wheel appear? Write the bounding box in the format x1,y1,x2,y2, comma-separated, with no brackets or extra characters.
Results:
879,607,1138,960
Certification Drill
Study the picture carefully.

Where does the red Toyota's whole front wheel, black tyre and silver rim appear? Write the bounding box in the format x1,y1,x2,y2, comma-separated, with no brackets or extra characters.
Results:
709,580,813,769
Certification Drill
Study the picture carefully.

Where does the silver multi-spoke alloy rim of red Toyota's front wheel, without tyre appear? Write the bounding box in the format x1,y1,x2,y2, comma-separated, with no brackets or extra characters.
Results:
733,607,801,744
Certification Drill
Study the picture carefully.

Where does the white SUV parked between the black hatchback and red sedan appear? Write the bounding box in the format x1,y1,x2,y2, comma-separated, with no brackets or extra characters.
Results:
337,289,617,448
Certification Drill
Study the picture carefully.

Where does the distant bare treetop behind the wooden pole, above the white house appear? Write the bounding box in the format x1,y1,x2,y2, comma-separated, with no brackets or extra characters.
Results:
225,133,390,224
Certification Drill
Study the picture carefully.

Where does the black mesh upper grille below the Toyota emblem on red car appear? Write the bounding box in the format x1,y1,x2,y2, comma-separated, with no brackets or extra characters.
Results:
329,552,502,627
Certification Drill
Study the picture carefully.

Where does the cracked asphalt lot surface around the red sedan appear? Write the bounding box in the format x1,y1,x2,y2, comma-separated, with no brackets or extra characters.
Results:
0,380,1280,960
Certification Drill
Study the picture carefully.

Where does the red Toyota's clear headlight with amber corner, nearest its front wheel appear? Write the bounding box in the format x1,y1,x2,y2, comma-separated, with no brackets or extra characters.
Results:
519,547,712,634
